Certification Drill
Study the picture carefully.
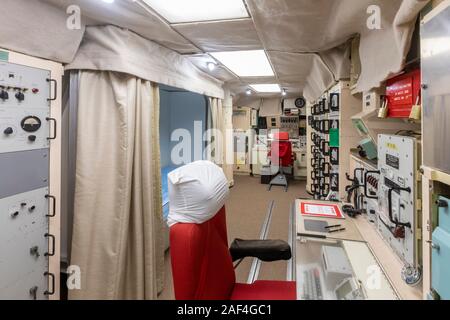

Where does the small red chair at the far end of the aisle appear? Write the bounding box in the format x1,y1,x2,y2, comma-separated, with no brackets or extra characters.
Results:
269,132,294,191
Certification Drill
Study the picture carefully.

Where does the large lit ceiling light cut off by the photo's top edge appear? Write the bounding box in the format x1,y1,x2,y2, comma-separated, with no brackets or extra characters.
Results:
143,0,249,23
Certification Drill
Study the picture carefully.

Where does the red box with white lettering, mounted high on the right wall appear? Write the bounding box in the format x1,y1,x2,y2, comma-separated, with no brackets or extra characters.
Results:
386,69,421,118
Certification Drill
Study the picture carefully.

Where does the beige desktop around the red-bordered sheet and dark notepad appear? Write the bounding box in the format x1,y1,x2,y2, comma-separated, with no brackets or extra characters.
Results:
295,199,364,241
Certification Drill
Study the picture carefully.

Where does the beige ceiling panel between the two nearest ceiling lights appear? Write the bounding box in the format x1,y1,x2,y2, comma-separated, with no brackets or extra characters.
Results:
173,19,263,52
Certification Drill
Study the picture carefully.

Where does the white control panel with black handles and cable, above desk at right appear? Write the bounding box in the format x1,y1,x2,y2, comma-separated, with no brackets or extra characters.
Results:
377,135,421,276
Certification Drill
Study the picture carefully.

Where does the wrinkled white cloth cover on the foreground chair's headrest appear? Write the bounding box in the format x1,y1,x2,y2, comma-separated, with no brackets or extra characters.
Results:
167,161,229,227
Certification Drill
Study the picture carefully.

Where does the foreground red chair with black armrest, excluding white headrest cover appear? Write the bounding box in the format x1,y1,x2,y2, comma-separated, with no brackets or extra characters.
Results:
170,207,296,300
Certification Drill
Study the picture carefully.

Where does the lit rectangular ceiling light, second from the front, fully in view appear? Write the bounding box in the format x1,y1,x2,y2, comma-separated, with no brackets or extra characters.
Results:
210,50,274,77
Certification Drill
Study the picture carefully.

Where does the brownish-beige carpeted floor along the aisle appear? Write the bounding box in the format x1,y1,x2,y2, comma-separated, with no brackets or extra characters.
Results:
159,176,307,300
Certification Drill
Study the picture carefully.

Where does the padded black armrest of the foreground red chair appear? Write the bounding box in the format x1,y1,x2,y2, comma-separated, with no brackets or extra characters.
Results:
230,239,292,262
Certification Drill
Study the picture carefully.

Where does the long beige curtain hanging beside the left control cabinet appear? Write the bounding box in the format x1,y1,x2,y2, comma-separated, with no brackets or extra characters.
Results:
69,71,164,299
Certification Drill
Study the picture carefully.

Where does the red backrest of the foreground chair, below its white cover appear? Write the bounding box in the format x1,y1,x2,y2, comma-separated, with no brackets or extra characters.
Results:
170,207,236,300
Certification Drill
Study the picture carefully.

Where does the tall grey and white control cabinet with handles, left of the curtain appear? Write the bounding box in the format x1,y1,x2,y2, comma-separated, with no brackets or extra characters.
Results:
0,62,56,300
